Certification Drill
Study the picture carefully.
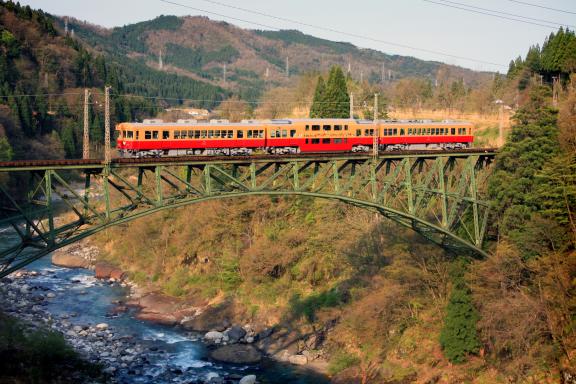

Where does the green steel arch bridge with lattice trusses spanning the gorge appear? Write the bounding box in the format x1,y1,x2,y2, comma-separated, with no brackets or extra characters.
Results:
0,149,496,277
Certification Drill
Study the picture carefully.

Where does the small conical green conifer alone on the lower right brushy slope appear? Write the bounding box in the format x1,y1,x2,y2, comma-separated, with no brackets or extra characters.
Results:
440,260,480,363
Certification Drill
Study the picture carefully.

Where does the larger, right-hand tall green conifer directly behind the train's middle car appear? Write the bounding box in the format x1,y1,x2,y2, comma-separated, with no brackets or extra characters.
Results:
321,66,350,118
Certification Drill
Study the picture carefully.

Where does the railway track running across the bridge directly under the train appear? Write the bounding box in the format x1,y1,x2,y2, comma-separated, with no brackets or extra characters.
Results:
0,148,497,170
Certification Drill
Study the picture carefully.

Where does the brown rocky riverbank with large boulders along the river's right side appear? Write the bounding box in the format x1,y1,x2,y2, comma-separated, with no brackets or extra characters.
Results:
52,241,327,374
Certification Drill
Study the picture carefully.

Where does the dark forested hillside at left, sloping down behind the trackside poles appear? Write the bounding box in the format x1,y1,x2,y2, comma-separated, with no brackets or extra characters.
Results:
0,1,225,160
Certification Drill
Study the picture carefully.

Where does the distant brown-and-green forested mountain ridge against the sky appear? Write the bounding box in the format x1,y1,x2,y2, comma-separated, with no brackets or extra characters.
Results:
59,16,489,100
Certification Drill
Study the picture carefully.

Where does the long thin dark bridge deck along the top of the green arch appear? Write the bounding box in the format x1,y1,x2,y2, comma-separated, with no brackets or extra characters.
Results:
0,148,497,172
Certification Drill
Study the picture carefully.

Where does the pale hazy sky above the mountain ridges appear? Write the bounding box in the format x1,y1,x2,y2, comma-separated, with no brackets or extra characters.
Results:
20,0,576,73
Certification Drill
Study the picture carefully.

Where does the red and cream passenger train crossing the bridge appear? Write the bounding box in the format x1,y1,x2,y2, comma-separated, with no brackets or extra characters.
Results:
116,119,474,158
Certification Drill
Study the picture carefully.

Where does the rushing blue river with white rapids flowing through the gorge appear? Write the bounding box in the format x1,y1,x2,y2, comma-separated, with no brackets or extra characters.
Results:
0,225,329,384
